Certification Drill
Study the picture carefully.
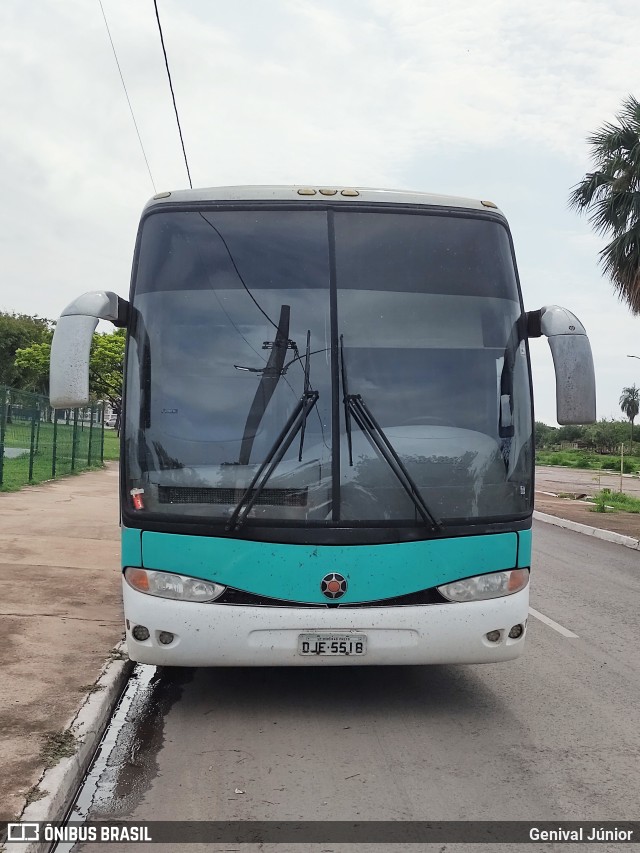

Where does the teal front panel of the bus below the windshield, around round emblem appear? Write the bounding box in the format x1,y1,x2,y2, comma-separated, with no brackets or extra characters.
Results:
142,531,518,604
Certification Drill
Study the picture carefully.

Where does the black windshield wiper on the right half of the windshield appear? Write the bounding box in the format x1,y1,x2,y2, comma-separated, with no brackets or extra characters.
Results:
340,335,442,531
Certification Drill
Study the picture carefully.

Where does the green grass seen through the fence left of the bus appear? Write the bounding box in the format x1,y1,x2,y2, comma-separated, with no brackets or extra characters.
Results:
0,421,120,492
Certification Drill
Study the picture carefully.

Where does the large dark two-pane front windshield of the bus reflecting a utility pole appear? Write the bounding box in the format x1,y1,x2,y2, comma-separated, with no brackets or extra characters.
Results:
124,205,533,536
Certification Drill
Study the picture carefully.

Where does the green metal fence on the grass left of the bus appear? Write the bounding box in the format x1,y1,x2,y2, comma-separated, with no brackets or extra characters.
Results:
0,385,104,488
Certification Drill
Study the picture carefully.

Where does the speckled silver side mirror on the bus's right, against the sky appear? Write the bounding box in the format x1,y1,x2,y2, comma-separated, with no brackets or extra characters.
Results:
527,305,596,424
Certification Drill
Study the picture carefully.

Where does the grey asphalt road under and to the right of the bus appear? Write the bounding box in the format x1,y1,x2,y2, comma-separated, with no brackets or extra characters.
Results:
67,523,640,853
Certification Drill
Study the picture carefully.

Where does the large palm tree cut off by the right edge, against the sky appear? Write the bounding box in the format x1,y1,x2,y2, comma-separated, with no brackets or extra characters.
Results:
569,95,640,314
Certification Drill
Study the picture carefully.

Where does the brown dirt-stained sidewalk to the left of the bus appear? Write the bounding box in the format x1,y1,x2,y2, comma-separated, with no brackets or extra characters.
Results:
0,463,122,818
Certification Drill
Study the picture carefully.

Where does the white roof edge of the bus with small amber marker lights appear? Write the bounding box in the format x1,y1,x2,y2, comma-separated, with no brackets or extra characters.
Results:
145,184,501,213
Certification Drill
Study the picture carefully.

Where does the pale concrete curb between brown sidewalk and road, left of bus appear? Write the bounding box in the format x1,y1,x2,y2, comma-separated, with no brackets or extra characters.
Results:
2,643,134,853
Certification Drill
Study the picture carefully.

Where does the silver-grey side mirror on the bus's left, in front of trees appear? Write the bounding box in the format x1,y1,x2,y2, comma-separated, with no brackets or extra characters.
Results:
49,290,129,409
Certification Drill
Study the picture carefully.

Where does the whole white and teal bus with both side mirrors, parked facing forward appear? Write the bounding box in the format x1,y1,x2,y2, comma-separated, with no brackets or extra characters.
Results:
51,186,595,666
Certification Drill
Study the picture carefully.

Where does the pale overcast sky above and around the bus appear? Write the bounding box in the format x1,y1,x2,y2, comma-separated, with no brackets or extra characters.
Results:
0,0,640,424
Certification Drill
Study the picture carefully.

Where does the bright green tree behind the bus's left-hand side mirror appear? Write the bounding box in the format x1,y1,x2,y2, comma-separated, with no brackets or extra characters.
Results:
15,329,125,412
